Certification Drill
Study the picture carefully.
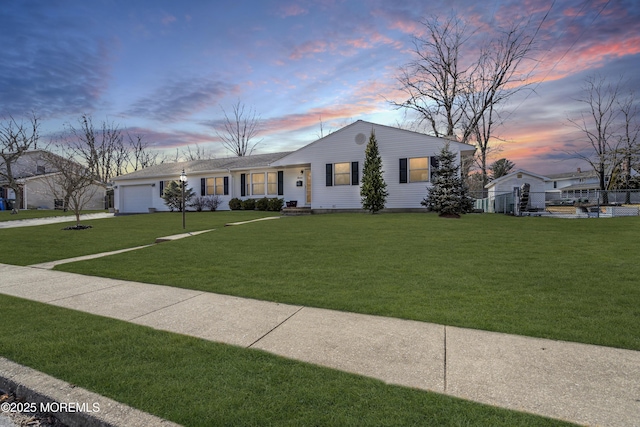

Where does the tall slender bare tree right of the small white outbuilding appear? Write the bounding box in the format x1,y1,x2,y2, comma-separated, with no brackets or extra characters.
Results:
569,76,622,203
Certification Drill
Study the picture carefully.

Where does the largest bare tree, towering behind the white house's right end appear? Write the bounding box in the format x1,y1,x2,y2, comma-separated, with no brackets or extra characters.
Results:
392,16,535,183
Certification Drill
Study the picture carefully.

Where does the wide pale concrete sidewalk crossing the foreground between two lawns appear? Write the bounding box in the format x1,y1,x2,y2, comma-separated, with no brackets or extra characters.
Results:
0,264,640,426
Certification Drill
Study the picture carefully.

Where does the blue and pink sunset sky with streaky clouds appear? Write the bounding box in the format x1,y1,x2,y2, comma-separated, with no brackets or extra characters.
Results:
0,0,640,174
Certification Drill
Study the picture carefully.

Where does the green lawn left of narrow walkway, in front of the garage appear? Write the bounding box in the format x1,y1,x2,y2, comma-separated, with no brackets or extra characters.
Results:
0,211,275,265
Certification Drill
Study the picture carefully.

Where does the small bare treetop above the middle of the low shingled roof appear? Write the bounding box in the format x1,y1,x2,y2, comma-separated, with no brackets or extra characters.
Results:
216,100,262,157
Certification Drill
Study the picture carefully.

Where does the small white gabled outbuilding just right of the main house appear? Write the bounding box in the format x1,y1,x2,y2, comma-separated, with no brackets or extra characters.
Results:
484,169,548,212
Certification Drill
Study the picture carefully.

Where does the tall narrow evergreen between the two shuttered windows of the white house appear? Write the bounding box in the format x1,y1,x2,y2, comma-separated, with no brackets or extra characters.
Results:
360,130,388,213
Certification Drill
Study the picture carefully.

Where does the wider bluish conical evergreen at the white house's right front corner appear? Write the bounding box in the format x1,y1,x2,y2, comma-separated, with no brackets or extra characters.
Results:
422,142,473,218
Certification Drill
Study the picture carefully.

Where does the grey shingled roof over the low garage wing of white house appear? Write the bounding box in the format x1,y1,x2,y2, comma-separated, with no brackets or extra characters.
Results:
113,151,290,181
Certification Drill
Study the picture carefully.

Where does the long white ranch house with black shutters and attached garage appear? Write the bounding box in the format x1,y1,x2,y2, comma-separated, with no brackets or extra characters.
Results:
113,120,475,213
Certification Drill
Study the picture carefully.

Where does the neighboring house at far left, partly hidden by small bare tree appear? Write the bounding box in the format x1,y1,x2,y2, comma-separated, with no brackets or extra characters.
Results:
0,150,106,209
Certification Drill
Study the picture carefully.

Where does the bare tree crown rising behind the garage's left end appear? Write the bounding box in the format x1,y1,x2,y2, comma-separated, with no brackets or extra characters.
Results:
67,114,129,182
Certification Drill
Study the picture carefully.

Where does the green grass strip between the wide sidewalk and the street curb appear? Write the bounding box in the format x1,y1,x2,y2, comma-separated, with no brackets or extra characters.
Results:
0,295,569,426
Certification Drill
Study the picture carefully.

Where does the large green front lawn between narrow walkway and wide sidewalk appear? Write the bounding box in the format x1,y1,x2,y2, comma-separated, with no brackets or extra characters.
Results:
51,214,640,350
